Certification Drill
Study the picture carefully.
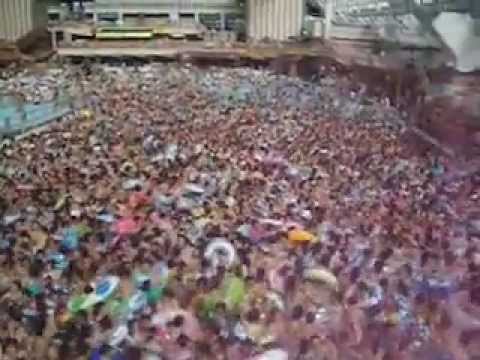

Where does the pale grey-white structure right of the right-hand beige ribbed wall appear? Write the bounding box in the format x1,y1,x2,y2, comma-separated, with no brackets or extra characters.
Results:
316,0,480,72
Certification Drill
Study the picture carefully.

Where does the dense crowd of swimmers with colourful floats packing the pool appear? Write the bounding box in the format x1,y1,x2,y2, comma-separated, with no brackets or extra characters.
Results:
0,64,480,360
